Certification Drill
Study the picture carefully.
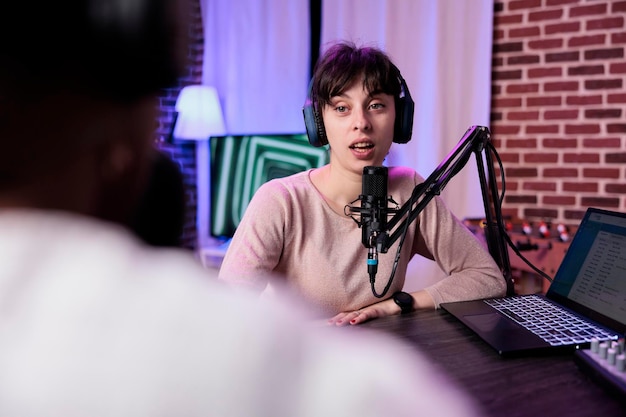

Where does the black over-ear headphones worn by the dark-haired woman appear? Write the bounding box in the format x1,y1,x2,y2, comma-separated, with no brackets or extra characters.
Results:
302,68,415,148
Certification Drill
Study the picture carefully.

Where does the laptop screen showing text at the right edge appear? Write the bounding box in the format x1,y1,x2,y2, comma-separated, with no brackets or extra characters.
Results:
547,208,626,328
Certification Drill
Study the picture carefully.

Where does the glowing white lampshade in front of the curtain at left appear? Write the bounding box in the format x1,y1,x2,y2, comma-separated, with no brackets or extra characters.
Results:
173,85,226,140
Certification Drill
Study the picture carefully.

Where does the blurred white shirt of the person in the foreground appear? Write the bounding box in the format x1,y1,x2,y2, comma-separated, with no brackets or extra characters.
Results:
0,210,476,417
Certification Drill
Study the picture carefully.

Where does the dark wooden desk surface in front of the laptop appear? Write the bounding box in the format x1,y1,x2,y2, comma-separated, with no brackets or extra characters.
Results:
354,310,626,417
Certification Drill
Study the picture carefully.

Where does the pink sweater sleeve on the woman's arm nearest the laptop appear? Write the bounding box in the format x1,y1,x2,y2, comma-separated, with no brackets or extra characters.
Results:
415,197,506,308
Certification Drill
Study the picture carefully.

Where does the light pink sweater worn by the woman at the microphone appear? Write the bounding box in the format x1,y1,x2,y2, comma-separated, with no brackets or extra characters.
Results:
219,167,506,315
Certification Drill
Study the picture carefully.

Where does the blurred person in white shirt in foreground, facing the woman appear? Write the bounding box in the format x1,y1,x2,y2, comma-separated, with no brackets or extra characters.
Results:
0,0,475,417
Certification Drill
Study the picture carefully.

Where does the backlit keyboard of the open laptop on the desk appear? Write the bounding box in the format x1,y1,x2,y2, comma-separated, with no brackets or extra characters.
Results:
485,295,617,346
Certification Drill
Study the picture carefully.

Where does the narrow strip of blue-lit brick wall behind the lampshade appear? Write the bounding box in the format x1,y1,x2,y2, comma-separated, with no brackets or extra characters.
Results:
155,0,204,249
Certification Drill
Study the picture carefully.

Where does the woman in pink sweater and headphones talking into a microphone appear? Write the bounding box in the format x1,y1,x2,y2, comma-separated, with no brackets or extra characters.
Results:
220,42,506,326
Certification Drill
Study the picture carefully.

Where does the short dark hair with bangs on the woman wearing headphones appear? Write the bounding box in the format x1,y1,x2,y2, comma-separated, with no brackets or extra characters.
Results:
311,41,402,111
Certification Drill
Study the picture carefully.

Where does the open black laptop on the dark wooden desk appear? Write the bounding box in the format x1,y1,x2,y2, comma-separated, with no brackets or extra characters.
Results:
441,208,626,356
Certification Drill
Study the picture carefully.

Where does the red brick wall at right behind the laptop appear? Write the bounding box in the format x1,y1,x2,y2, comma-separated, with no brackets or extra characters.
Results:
491,0,626,228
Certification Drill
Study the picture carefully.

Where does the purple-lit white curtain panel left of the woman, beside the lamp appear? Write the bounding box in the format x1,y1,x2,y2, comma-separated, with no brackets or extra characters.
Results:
200,0,310,134
